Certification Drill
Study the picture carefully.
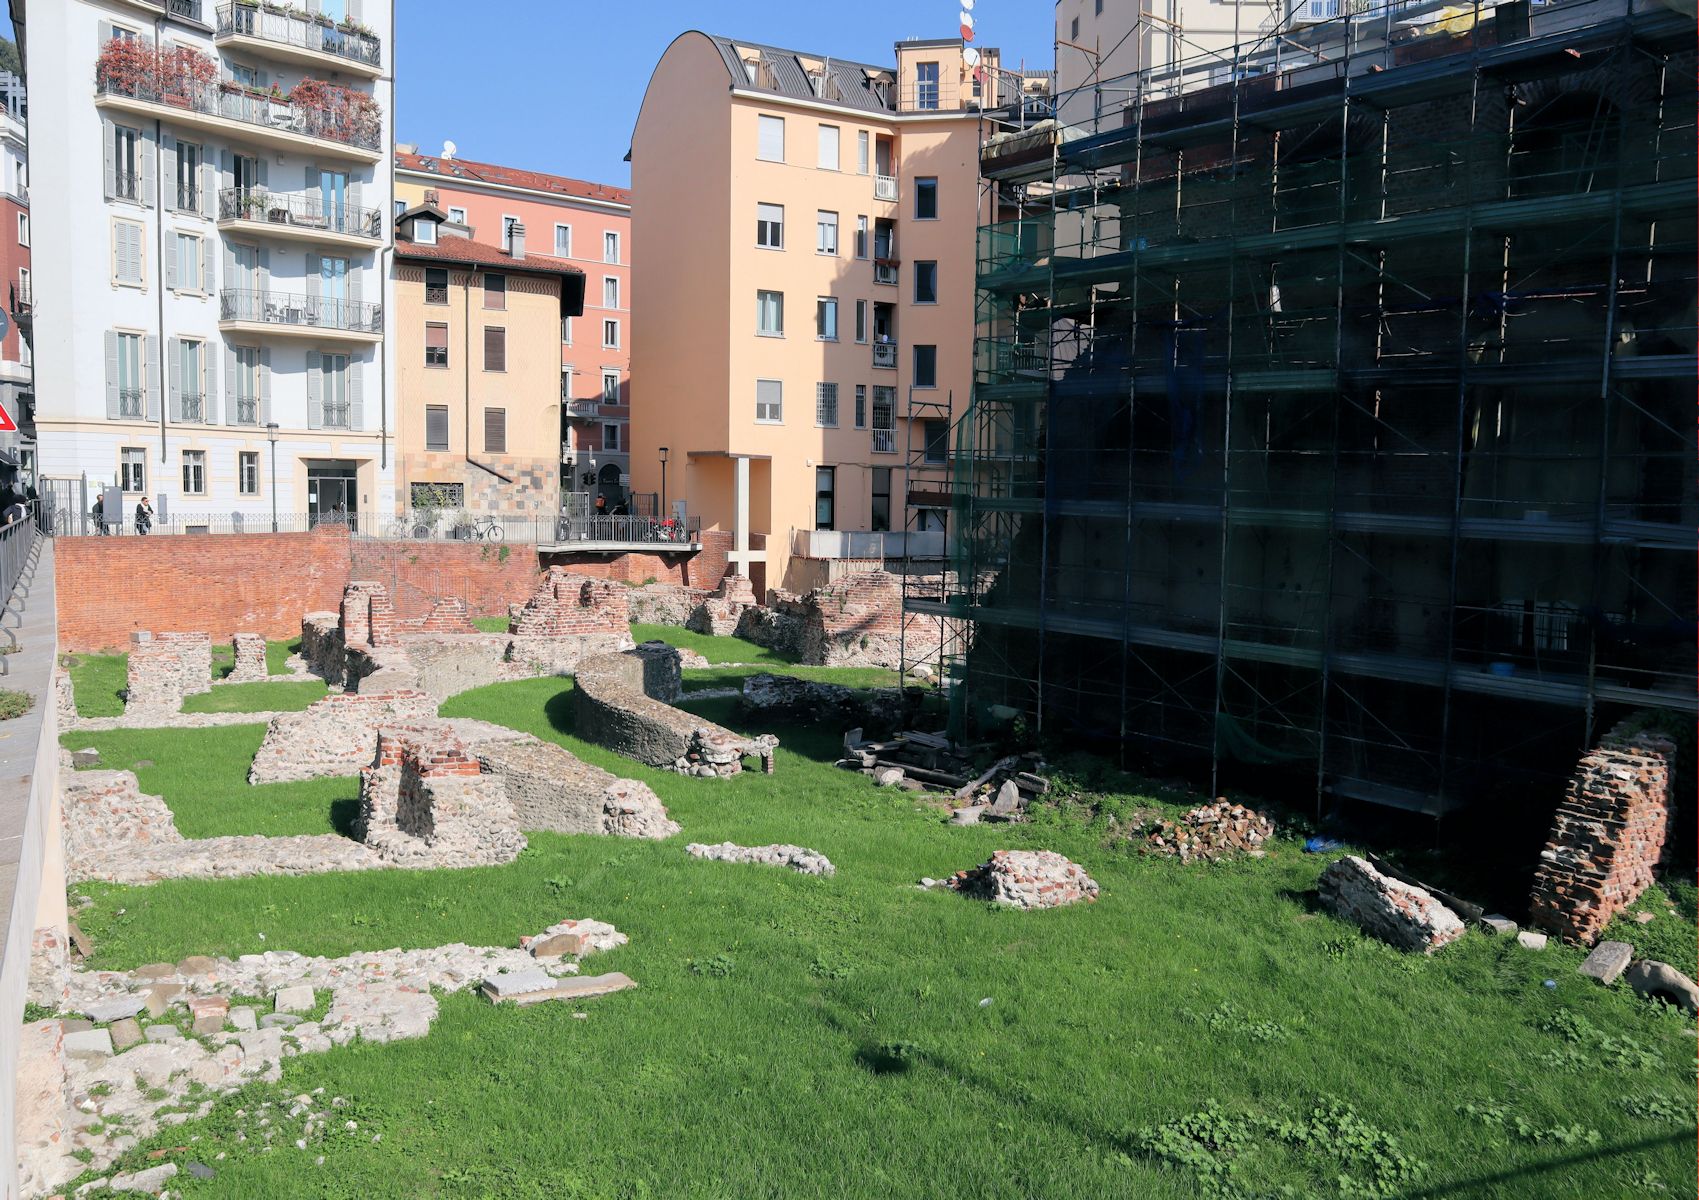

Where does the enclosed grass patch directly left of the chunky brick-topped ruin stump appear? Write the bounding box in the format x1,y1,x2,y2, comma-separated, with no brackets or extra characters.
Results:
59,724,360,838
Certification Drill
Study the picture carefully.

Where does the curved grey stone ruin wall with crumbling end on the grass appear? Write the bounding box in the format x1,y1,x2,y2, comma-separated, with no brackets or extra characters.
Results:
573,642,778,778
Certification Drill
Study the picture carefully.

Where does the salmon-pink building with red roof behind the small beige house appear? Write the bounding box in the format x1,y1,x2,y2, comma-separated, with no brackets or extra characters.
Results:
394,146,632,505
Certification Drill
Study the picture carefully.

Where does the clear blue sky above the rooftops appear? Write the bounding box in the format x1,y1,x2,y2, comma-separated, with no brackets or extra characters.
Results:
394,0,1055,185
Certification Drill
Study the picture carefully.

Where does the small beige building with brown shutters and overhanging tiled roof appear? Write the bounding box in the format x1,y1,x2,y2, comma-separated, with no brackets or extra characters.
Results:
392,204,584,520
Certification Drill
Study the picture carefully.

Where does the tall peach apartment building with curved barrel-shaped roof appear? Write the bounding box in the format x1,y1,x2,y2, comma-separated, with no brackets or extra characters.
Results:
630,32,996,592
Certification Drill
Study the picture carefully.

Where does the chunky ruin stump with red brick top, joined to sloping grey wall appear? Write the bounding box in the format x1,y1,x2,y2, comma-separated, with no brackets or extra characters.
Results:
353,724,525,869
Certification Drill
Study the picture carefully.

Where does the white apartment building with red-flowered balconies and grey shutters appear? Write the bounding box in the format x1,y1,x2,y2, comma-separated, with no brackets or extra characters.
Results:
12,0,394,529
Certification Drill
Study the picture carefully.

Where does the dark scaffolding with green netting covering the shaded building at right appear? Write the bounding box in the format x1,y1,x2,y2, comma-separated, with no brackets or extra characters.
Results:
944,0,1699,816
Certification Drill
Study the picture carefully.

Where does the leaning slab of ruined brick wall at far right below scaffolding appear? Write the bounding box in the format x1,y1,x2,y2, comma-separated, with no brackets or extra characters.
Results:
1529,722,1675,945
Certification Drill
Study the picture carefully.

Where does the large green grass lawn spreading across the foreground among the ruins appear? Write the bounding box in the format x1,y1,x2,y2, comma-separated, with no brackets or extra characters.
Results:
56,680,1699,1200
